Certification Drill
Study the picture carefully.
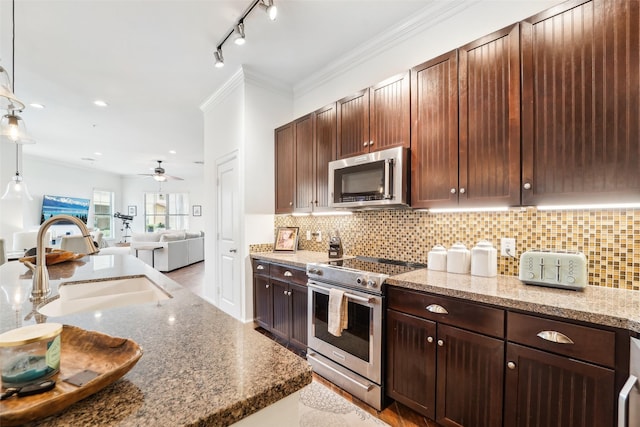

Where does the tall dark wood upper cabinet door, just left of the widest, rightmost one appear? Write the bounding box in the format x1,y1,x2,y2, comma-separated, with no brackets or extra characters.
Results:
458,24,520,206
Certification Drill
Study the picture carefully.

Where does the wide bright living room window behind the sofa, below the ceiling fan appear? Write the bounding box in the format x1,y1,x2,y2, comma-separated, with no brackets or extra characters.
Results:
144,193,189,232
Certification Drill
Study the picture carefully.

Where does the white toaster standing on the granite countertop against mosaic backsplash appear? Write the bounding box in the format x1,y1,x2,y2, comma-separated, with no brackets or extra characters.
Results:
519,250,589,290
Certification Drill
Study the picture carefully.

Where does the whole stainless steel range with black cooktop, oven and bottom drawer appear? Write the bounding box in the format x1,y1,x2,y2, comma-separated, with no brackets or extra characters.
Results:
307,257,426,410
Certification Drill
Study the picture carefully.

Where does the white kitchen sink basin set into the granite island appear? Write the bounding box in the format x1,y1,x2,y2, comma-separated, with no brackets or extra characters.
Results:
38,276,172,317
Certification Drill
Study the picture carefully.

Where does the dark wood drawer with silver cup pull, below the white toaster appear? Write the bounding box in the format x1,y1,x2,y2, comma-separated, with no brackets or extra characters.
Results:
507,312,616,367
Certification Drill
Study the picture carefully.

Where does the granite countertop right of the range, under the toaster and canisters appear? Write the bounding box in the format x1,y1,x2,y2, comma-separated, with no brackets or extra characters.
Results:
386,269,640,333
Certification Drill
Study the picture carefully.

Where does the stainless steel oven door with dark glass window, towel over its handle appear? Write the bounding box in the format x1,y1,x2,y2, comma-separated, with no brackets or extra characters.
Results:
307,280,382,384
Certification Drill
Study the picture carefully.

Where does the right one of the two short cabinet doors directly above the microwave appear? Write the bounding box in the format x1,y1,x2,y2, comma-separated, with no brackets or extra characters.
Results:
369,72,411,151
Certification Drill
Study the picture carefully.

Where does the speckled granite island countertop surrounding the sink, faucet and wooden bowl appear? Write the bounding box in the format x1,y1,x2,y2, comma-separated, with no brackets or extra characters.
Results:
0,255,311,426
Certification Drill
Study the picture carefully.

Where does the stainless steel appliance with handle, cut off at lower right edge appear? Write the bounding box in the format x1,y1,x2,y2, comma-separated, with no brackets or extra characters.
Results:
618,338,640,427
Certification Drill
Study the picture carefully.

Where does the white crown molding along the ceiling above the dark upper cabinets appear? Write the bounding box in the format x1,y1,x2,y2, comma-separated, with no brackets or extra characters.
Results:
293,0,480,98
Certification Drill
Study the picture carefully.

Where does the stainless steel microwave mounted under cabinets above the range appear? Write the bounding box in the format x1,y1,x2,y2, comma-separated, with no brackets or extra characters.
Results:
329,147,409,209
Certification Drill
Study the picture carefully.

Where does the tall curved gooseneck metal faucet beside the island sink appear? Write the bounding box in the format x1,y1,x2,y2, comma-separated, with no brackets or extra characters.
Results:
25,215,99,300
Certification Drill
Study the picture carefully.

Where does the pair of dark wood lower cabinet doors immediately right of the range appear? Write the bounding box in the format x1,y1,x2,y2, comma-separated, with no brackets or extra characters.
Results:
387,310,504,427
